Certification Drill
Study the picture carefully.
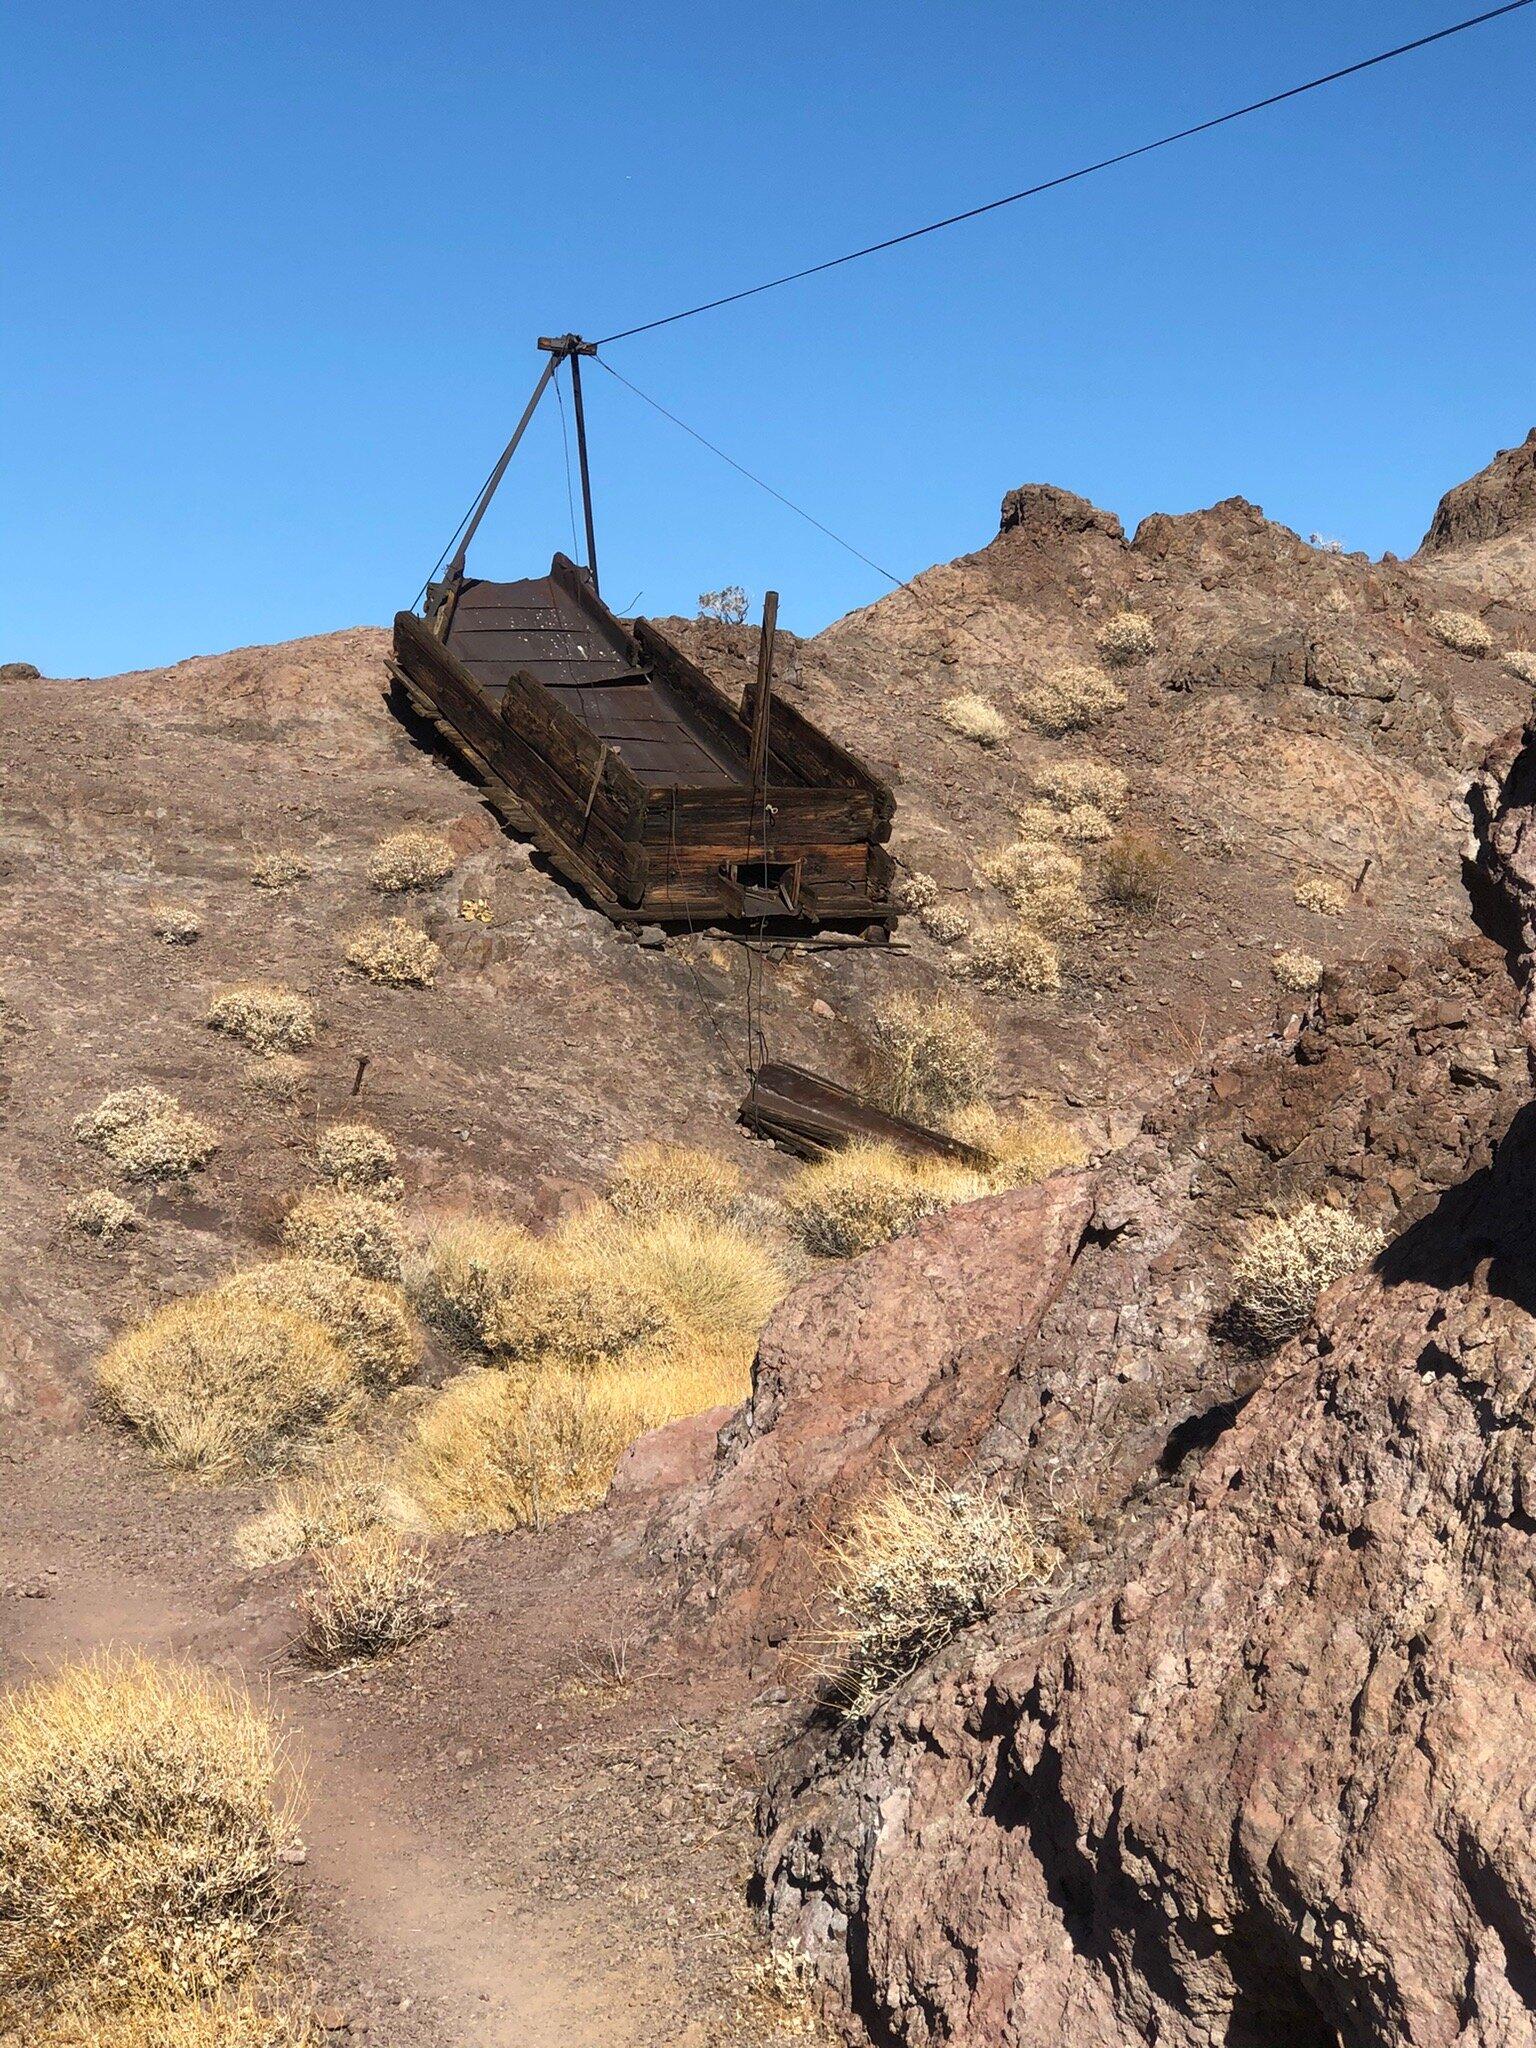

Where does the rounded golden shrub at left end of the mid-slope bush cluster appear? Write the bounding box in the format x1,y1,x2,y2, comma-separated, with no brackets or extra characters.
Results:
96,1290,360,1473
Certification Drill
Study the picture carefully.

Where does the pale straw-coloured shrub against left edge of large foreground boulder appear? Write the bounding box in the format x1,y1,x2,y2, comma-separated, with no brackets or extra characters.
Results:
825,1468,1055,1718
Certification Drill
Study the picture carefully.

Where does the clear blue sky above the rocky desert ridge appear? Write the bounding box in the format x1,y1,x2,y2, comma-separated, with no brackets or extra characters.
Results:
0,0,1536,676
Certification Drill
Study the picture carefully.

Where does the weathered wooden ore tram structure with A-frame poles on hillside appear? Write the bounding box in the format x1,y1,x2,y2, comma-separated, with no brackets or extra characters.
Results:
389,334,895,938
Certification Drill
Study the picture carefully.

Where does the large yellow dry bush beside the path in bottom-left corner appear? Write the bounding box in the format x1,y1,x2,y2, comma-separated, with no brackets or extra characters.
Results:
0,1655,293,2015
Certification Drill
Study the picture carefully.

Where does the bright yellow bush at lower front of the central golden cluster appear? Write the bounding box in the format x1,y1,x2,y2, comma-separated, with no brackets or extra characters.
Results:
399,1370,647,1534
